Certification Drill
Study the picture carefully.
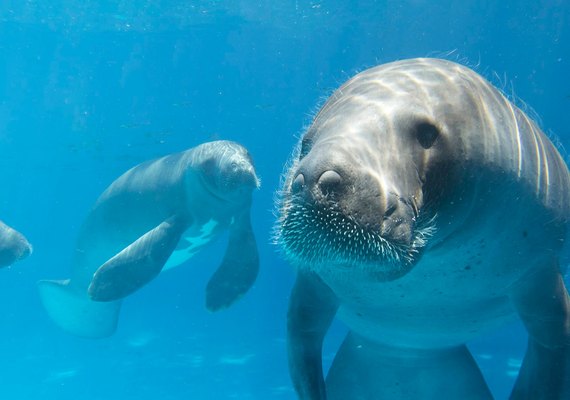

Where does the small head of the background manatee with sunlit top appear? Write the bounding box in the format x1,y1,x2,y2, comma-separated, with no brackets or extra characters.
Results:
193,140,260,203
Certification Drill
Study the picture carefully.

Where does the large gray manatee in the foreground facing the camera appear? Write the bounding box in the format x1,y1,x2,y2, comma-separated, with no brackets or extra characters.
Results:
277,59,570,400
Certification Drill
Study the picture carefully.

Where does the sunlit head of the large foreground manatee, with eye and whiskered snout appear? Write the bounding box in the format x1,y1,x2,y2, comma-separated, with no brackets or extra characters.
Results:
276,59,474,281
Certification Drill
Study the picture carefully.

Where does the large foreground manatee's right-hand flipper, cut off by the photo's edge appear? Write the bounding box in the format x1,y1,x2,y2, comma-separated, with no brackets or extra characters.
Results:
511,261,570,400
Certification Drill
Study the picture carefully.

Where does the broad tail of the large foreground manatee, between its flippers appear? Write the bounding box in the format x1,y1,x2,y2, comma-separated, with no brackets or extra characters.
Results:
326,332,493,400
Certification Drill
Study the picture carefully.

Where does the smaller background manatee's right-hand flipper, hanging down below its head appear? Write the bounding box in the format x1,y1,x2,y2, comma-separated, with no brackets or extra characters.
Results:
206,210,259,311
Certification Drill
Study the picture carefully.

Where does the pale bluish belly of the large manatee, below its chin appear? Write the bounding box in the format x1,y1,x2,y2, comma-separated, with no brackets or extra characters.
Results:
319,228,532,348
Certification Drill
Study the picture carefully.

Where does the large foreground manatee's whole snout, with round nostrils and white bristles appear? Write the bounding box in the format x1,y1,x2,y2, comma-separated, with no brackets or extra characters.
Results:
277,153,426,270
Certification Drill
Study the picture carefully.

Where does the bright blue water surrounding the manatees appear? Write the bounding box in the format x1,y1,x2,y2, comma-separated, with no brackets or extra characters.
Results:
0,0,570,400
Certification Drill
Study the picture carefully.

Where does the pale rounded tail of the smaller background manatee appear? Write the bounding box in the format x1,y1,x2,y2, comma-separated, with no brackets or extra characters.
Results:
38,280,121,339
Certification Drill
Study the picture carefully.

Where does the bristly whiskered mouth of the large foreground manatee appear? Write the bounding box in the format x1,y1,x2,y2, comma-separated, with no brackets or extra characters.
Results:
276,199,435,280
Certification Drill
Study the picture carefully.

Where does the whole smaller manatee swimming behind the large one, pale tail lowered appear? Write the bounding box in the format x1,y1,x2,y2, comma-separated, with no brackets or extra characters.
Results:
39,141,259,338
